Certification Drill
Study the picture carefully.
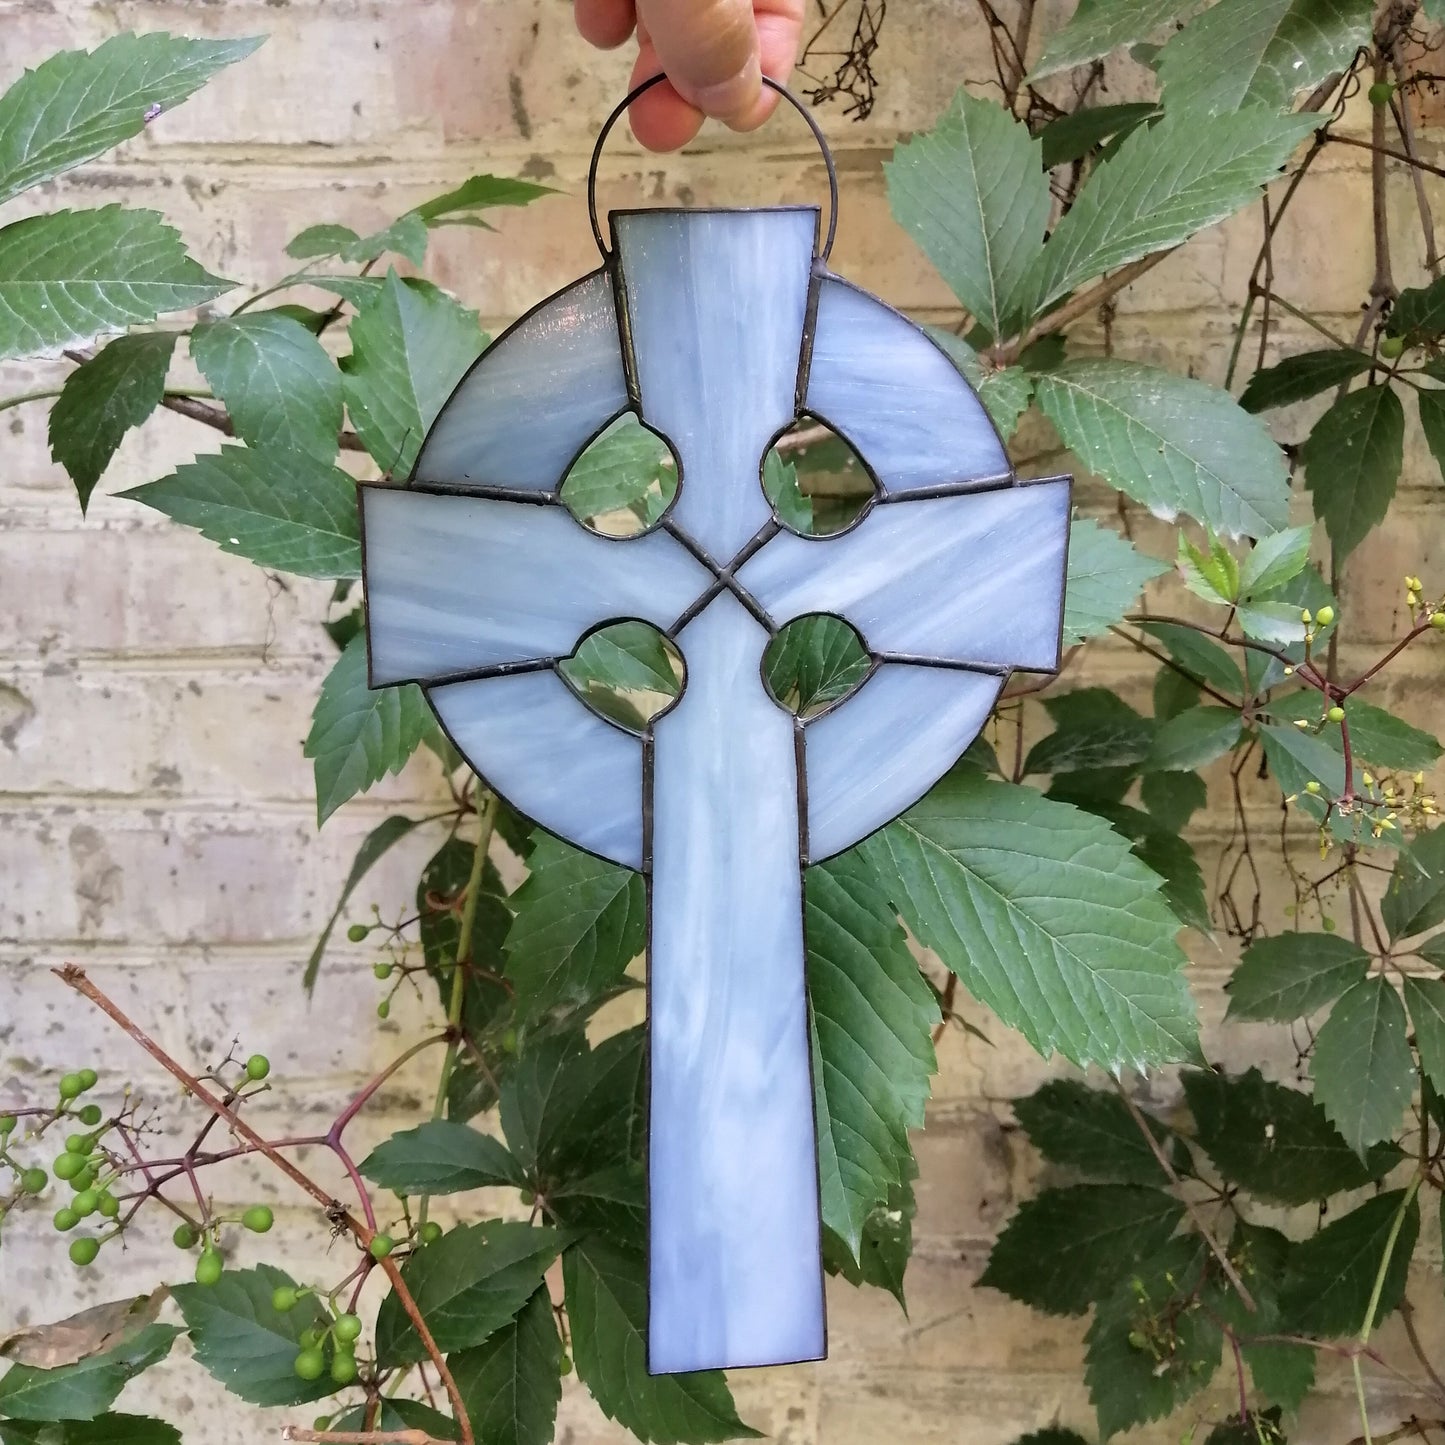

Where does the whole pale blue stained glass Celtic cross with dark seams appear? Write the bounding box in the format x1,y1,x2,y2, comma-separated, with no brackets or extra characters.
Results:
361,79,1069,1373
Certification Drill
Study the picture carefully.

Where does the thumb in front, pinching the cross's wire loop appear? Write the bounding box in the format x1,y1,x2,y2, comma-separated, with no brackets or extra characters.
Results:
637,0,763,121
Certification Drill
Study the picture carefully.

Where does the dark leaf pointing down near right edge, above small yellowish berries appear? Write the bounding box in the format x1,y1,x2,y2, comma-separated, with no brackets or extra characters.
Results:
1299,386,1405,556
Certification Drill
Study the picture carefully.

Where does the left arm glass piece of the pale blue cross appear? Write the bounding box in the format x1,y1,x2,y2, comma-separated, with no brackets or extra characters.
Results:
361,487,711,685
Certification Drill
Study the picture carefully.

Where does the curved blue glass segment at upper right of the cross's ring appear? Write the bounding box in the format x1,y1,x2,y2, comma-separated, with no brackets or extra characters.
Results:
808,276,1010,496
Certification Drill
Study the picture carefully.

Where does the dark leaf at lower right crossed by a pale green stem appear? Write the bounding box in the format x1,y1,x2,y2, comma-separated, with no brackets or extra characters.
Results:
1280,1189,1420,1338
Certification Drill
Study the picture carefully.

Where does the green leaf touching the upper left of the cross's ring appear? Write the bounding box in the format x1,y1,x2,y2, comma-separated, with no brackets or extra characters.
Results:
342,270,487,475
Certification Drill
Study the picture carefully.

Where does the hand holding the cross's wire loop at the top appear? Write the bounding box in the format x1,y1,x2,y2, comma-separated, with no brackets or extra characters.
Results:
574,0,805,150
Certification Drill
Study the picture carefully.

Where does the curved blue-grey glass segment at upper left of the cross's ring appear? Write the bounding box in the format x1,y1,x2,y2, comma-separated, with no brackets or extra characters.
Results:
413,272,627,491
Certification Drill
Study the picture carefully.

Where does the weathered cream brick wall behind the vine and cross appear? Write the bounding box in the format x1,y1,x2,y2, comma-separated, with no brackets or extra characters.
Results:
0,0,1445,1445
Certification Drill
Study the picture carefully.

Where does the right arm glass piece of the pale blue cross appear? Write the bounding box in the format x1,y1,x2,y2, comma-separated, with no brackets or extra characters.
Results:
738,481,1069,672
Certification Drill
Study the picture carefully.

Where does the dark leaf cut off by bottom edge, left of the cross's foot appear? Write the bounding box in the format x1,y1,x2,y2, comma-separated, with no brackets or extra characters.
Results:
447,1286,562,1445
